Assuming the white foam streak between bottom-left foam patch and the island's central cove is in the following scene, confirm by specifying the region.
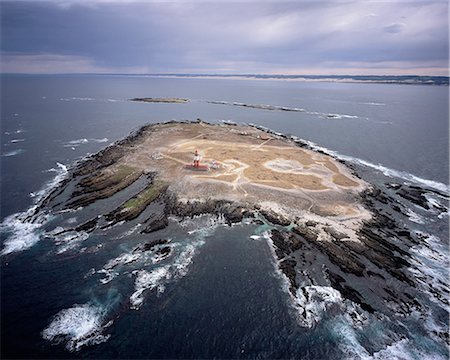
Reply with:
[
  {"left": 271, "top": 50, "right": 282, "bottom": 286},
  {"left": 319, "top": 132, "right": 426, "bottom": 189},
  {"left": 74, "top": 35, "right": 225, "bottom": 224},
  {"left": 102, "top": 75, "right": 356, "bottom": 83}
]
[{"left": 130, "top": 265, "right": 171, "bottom": 310}]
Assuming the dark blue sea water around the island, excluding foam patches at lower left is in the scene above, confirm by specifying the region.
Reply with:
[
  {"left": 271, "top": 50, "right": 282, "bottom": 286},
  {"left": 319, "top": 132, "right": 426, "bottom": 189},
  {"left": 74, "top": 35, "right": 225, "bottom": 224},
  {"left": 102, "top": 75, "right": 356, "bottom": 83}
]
[{"left": 1, "top": 76, "right": 449, "bottom": 358}]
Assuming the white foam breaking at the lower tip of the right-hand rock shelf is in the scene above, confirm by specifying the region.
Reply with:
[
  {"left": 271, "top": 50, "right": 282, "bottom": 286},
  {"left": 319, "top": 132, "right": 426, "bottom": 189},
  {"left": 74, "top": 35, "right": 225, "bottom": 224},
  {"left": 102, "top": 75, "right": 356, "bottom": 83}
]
[{"left": 295, "top": 285, "right": 343, "bottom": 328}]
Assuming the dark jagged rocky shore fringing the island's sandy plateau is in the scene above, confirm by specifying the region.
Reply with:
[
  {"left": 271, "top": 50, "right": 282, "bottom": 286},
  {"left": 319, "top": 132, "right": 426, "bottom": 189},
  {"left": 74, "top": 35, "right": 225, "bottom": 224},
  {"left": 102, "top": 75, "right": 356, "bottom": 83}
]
[{"left": 39, "top": 122, "right": 449, "bottom": 344}]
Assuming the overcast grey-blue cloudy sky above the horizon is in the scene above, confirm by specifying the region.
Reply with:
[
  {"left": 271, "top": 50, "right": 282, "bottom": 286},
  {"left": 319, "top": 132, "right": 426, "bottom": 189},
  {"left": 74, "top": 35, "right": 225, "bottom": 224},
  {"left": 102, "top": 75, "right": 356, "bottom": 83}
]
[{"left": 0, "top": 0, "right": 449, "bottom": 75}]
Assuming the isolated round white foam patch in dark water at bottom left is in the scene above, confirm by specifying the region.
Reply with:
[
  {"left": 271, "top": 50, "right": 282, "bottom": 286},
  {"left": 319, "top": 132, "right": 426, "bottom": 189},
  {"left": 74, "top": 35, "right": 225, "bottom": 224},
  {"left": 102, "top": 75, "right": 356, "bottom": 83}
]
[{"left": 42, "top": 303, "right": 112, "bottom": 351}]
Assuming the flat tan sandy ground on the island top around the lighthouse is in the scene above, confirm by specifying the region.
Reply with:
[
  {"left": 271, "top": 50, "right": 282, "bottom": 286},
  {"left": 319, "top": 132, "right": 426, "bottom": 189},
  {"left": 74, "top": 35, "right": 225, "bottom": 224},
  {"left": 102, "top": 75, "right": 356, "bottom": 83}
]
[{"left": 117, "top": 123, "right": 367, "bottom": 226}]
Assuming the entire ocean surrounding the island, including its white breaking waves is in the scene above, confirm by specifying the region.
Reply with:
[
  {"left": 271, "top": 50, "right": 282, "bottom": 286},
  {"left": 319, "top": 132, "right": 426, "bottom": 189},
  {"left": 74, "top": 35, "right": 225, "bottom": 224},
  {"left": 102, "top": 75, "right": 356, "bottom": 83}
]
[{"left": 0, "top": 75, "right": 449, "bottom": 359}]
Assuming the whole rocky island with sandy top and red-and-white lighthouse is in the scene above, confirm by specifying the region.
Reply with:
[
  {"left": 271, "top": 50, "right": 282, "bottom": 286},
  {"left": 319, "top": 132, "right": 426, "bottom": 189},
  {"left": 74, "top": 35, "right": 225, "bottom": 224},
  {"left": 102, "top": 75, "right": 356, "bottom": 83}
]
[{"left": 36, "top": 120, "right": 448, "bottom": 334}]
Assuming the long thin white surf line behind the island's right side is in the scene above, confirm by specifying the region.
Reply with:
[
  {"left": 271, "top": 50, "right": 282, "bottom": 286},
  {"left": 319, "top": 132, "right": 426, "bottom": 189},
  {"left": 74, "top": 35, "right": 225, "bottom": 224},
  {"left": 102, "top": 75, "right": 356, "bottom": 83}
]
[{"left": 304, "top": 141, "right": 450, "bottom": 194}]
